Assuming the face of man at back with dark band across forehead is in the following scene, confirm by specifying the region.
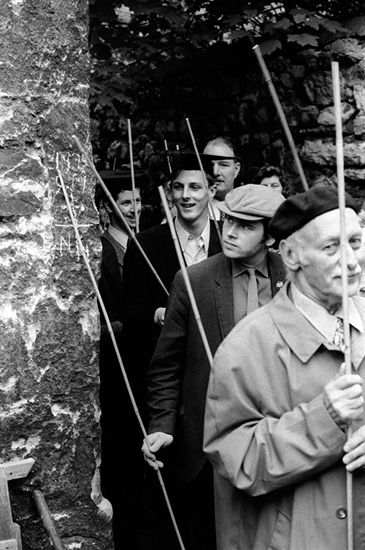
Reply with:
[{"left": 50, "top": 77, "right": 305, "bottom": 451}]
[{"left": 204, "top": 143, "right": 240, "bottom": 201}]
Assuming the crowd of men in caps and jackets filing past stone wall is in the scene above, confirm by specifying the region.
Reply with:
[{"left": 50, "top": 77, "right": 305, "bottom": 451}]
[{"left": 95, "top": 138, "right": 365, "bottom": 550}]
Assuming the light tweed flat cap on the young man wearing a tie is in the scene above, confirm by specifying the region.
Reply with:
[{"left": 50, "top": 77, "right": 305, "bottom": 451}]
[{"left": 218, "top": 183, "right": 285, "bottom": 221}]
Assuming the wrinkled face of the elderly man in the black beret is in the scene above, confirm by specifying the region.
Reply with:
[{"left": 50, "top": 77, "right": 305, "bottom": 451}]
[{"left": 297, "top": 208, "right": 365, "bottom": 309}]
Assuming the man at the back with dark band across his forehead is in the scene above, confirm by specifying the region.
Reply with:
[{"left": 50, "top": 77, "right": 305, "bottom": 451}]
[{"left": 202, "top": 137, "right": 241, "bottom": 220}]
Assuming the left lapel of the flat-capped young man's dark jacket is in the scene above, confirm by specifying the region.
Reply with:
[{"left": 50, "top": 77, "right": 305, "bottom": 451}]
[{"left": 214, "top": 254, "right": 233, "bottom": 339}]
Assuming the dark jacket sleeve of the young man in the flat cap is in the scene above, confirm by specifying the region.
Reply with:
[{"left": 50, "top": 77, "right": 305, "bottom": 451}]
[{"left": 147, "top": 271, "right": 190, "bottom": 435}]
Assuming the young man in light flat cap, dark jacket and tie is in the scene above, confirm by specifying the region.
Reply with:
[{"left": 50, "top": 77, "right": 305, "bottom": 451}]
[{"left": 143, "top": 185, "right": 285, "bottom": 550}]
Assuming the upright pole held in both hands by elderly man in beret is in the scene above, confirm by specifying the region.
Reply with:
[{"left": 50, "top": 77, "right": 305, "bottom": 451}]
[{"left": 331, "top": 62, "right": 353, "bottom": 550}]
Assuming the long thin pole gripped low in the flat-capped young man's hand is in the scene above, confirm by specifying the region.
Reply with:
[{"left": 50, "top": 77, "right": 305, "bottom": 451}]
[{"left": 57, "top": 166, "right": 185, "bottom": 550}]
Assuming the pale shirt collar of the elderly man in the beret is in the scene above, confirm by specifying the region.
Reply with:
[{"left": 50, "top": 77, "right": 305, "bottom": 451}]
[{"left": 291, "top": 283, "right": 364, "bottom": 342}]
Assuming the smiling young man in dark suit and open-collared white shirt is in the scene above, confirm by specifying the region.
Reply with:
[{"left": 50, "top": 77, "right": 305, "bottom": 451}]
[{"left": 122, "top": 153, "right": 222, "bottom": 422}]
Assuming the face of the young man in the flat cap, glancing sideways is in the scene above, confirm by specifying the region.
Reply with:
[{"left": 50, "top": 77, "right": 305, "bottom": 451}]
[{"left": 222, "top": 214, "right": 270, "bottom": 265}]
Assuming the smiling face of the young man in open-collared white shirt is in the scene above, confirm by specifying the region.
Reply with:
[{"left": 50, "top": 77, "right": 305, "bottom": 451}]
[{"left": 171, "top": 170, "right": 214, "bottom": 227}]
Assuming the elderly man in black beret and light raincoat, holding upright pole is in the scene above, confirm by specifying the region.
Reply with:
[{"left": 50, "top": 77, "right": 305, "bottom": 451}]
[{"left": 204, "top": 187, "right": 365, "bottom": 550}]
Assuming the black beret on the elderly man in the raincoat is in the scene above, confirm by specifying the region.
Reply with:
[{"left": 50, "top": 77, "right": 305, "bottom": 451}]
[{"left": 269, "top": 185, "right": 358, "bottom": 241}]
